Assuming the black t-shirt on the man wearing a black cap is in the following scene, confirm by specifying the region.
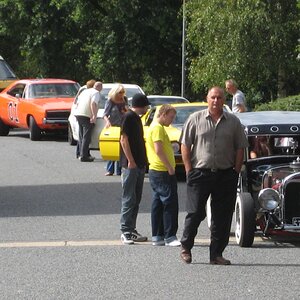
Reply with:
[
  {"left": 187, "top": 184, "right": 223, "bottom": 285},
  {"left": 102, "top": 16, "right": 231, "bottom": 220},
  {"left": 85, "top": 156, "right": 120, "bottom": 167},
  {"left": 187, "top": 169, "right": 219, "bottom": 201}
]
[{"left": 120, "top": 110, "right": 147, "bottom": 168}]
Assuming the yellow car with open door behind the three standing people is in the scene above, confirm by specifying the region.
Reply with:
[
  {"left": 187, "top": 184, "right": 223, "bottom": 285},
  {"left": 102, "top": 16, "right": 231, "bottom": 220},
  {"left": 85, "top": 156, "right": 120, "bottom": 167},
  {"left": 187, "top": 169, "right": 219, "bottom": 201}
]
[{"left": 99, "top": 102, "right": 231, "bottom": 166}]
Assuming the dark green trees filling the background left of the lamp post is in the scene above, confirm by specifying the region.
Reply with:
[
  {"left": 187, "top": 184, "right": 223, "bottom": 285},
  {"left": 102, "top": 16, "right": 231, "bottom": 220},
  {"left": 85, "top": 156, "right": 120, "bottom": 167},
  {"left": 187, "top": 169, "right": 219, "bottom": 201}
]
[{"left": 0, "top": 0, "right": 182, "bottom": 93}]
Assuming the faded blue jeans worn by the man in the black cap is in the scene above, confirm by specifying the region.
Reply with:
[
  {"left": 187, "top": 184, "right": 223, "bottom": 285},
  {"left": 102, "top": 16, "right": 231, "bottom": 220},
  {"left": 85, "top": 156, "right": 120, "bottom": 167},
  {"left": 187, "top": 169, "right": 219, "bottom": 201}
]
[{"left": 120, "top": 168, "right": 145, "bottom": 232}]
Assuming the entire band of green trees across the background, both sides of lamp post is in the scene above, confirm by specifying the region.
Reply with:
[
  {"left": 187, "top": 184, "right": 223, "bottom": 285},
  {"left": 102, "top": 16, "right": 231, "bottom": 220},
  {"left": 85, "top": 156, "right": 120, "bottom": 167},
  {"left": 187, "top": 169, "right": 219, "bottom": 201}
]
[{"left": 0, "top": 0, "right": 300, "bottom": 102}]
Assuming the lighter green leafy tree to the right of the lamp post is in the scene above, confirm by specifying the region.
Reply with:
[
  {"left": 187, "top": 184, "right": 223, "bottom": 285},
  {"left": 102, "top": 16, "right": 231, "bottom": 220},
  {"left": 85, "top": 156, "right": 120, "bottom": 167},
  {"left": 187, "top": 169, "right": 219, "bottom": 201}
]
[{"left": 187, "top": 0, "right": 300, "bottom": 102}]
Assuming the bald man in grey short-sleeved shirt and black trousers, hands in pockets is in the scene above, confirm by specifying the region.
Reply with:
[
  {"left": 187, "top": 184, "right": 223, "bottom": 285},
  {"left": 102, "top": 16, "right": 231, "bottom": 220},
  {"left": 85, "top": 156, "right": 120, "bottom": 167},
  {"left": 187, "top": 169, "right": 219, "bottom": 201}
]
[{"left": 180, "top": 87, "right": 248, "bottom": 265}]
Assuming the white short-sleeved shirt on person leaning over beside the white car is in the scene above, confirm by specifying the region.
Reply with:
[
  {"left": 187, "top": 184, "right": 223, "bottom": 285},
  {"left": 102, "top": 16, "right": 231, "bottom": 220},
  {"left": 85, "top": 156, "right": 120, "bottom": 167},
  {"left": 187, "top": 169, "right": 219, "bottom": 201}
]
[{"left": 74, "top": 88, "right": 101, "bottom": 118}]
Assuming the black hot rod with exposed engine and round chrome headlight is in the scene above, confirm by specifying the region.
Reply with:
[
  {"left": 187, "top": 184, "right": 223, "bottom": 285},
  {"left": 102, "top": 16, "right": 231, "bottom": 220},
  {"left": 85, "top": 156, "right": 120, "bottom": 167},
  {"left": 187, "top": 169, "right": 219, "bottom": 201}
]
[{"left": 234, "top": 111, "right": 300, "bottom": 247}]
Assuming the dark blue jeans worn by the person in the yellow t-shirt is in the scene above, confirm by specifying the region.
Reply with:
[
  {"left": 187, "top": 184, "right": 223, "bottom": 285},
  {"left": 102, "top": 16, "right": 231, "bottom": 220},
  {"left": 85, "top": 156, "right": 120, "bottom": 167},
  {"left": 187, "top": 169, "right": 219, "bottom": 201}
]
[{"left": 149, "top": 170, "right": 178, "bottom": 243}]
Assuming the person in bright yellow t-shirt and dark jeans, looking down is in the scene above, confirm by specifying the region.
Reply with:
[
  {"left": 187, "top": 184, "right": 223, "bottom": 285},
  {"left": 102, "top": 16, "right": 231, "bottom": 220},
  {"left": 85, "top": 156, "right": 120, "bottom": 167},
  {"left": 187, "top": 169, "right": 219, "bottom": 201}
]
[{"left": 146, "top": 104, "right": 181, "bottom": 246}]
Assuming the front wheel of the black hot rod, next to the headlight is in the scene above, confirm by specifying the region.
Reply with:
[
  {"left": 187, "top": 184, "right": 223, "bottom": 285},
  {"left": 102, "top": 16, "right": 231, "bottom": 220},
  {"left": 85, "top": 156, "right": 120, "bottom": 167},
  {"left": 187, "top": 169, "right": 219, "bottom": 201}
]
[{"left": 234, "top": 193, "right": 255, "bottom": 247}]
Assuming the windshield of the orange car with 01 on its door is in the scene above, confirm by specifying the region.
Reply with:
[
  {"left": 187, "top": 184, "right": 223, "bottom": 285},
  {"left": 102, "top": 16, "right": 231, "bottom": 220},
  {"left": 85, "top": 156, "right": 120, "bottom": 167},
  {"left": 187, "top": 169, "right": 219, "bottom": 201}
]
[{"left": 28, "top": 83, "right": 78, "bottom": 98}]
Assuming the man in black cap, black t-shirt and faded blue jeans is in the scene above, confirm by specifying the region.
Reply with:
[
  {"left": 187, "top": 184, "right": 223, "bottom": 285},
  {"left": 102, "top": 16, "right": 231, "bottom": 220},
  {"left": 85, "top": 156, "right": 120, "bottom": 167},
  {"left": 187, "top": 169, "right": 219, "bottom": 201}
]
[{"left": 120, "top": 94, "right": 150, "bottom": 245}]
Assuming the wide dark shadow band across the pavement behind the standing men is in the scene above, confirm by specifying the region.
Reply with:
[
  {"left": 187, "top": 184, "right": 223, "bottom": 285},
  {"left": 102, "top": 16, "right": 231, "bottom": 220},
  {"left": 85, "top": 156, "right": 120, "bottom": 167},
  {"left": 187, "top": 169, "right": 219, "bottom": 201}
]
[{"left": 0, "top": 182, "right": 188, "bottom": 218}]
